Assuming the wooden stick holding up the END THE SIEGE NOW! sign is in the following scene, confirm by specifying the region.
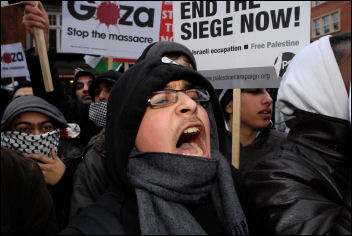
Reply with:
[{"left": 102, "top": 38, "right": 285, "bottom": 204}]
[{"left": 232, "top": 89, "right": 241, "bottom": 169}]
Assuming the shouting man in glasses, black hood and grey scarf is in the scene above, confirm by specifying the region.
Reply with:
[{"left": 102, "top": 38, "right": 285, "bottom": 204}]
[{"left": 61, "top": 56, "right": 248, "bottom": 235}]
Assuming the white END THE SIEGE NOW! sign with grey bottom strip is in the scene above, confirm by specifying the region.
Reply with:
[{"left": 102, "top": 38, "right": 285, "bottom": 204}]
[{"left": 173, "top": 1, "right": 310, "bottom": 88}]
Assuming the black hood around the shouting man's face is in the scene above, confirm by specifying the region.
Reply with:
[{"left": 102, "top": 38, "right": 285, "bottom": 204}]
[{"left": 105, "top": 57, "right": 226, "bottom": 190}]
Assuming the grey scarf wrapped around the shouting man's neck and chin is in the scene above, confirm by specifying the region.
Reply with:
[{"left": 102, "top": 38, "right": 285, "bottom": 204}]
[{"left": 128, "top": 152, "right": 248, "bottom": 235}]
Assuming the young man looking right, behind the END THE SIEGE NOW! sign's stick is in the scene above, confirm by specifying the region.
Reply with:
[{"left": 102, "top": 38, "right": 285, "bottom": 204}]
[{"left": 219, "top": 88, "right": 286, "bottom": 174}]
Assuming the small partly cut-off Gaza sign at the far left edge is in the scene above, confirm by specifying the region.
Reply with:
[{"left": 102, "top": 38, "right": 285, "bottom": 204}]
[{"left": 1, "top": 43, "right": 29, "bottom": 78}]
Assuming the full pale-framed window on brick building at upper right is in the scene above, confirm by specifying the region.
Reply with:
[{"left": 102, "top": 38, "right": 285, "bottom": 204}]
[{"left": 312, "top": 11, "right": 340, "bottom": 38}]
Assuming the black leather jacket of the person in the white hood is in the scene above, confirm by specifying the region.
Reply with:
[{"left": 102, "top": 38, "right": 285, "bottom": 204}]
[{"left": 242, "top": 110, "right": 351, "bottom": 235}]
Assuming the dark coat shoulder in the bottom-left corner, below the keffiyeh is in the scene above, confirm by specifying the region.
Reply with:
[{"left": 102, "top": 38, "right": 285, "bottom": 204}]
[{"left": 1, "top": 147, "right": 58, "bottom": 235}]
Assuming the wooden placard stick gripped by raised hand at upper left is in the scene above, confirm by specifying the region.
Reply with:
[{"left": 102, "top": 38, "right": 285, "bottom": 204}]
[{"left": 34, "top": 1, "right": 54, "bottom": 92}]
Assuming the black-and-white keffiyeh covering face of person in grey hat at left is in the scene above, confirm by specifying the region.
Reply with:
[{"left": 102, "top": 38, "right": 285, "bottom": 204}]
[{"left": 1, "top": 129, "right": 60, "bottom": 158}]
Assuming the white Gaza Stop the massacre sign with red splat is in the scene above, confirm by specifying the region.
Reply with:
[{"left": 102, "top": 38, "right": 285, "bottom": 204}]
[{"left": 61, "top": 1, "right": 162, "bottom": 59}]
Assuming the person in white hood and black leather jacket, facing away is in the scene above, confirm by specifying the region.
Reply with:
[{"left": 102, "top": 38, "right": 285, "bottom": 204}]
[{"left": 242, "top": 32, "right": 351, "bottom": 235}]
